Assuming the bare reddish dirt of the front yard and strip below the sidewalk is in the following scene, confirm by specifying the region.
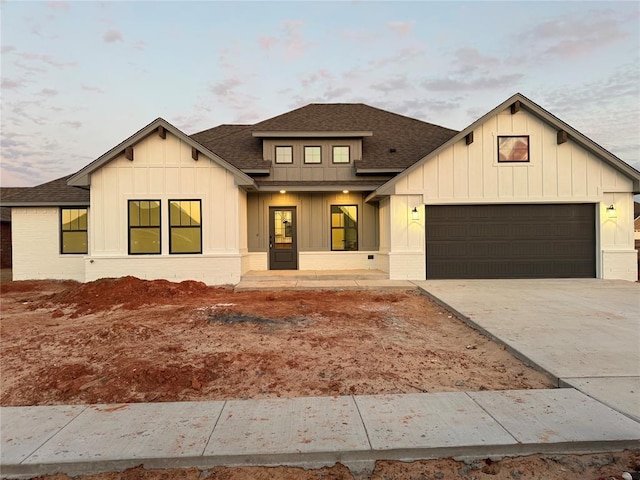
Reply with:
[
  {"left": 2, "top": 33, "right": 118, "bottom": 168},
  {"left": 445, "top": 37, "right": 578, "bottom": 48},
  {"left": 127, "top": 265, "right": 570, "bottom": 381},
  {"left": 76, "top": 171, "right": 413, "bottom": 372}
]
[{"left": 0, "top": 277, "right": 640, "bottom": 480}]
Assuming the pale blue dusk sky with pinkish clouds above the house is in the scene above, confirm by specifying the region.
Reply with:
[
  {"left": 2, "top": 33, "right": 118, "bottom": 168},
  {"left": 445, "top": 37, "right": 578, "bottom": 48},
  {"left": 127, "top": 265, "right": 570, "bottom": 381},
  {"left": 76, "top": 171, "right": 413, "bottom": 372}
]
[{"left": 0, "top": 1, "right": 640, "bottom": 187}]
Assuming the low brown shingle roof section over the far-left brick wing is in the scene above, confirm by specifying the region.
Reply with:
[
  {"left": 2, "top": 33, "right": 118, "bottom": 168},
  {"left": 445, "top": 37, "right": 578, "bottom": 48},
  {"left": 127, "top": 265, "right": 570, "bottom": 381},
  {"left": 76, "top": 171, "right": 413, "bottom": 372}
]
[{"left": 0, "top": 175, "right": 89, "bottom": 207}]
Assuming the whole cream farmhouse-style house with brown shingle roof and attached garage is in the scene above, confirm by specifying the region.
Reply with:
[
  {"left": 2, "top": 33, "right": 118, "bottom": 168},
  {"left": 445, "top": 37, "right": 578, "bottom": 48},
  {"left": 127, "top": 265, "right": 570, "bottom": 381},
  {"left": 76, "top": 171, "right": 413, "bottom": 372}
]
[{"left": 1, "top": 94, "right": 640, "bottom": 285}]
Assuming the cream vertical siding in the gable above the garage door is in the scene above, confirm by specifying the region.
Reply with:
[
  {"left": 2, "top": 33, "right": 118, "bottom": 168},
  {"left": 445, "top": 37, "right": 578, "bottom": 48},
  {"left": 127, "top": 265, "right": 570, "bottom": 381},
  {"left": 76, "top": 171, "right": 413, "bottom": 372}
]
[{"left": 395, "top": 109, "right": 632, "bottom": 203}]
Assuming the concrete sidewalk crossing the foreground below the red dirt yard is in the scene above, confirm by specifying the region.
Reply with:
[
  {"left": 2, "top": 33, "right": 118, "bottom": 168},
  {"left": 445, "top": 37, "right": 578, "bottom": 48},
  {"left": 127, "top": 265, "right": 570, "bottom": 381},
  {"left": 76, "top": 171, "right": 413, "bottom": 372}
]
[{"left": 0, "top": 388, "right": 640, "bottom": 478}]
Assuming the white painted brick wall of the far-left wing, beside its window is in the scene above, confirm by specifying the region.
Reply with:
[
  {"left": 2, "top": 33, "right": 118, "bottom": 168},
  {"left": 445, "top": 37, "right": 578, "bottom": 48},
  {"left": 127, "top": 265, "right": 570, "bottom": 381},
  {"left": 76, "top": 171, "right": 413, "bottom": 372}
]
[{"left": 11, "top": 207, "right": 85, "bottom": 282}]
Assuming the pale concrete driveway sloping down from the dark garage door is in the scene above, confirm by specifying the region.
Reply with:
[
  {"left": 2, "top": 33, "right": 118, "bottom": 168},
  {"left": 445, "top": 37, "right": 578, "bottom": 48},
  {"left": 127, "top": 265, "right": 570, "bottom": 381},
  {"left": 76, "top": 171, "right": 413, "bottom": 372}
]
[{"left": 415, "top": 279, "right": 640, "bottom": 420}]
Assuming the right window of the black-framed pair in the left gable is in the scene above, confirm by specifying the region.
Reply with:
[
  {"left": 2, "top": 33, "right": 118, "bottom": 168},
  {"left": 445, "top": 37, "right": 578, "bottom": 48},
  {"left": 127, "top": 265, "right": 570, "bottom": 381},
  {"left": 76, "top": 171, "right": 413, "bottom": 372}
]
[{"left": 169, "top": 200, "right": 202, "bottom": 253}]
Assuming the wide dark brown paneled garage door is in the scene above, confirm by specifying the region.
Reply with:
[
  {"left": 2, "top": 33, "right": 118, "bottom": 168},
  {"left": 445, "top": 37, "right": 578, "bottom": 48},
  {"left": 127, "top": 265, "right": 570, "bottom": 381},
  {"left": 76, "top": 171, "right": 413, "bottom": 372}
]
[{"left": 426, "top": 204, "right": 596, "bottom": 279}]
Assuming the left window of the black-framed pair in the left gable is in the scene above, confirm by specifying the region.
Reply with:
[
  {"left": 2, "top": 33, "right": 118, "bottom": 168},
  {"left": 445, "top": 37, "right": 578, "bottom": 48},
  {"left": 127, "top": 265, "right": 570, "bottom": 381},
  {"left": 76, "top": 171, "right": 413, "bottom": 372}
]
[{"left": 128, "top": 200, "right": 160, "bottom": 255}]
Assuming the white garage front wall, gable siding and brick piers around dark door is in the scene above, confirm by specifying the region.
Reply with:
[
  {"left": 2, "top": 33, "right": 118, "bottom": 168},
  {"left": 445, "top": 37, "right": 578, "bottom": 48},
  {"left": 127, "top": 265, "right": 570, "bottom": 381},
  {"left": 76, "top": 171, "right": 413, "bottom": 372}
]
[{"left": 390, "top": 109, "right": 637, "bottom": 280}]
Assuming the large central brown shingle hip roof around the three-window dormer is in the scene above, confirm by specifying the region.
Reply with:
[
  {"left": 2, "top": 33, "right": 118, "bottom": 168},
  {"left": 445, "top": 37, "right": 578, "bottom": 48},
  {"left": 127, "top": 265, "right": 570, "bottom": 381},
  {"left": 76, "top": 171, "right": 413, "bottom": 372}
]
[{"left": 191, "top": 103, "right": 458, "bottom": 170}]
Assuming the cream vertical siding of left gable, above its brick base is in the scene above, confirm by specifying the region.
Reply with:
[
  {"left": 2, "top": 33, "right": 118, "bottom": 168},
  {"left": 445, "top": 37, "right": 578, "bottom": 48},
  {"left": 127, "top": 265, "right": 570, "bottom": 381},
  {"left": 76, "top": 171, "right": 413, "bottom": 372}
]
[{"left": 90, "top": 133, "right": 240, "bottom": 256}]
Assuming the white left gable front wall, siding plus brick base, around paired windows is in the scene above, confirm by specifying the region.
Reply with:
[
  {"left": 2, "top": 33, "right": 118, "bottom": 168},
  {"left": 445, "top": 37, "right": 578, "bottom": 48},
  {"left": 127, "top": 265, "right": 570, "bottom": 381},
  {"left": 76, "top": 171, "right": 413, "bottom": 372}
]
[{"left": 85, "top": 133, "right": 246, "bottom": 284}]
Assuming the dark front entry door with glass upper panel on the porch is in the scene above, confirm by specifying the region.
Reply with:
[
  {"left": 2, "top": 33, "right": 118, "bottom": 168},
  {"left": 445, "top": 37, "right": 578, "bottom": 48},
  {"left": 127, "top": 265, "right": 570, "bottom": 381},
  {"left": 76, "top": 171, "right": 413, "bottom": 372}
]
[{"left": 269, "top": 207, "right": 298, "bottom": 270}]
